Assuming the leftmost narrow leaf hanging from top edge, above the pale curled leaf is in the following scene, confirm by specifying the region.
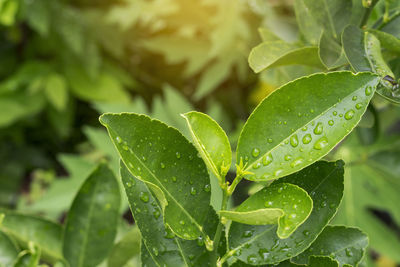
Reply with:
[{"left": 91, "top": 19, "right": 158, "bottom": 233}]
[{"left": 294, "top": 0, "right": 322, "bottom": 45}]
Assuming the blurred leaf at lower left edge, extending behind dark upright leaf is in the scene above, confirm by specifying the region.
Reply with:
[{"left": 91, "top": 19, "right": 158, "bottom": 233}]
[{"left": 0, "top": 210, "right": 62, "bottom": 263}]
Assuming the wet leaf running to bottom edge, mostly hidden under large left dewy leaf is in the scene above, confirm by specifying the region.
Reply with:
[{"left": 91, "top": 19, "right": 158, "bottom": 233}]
[{"left": 121, "top": 163, "right": 218, "bottom": 266}]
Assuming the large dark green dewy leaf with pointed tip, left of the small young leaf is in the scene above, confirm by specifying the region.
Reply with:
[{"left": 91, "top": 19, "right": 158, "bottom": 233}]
[{"left": 100, "top": 113, "right": 211, "bottom": 240}]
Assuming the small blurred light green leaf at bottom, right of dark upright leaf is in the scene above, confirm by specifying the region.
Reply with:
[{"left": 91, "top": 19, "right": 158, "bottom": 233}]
[{"left": 107, "top": 226, "right": 141, "bottom": 267}]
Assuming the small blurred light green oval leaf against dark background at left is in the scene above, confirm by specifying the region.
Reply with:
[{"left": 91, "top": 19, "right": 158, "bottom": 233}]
[{"left": 44, "top": 74, "right": 68, "bottom": 110}]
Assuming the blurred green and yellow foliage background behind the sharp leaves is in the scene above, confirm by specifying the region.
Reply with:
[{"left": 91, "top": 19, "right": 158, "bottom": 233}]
[{"left": 0, "top": 0, "right": 400, "bottom": 266}]
